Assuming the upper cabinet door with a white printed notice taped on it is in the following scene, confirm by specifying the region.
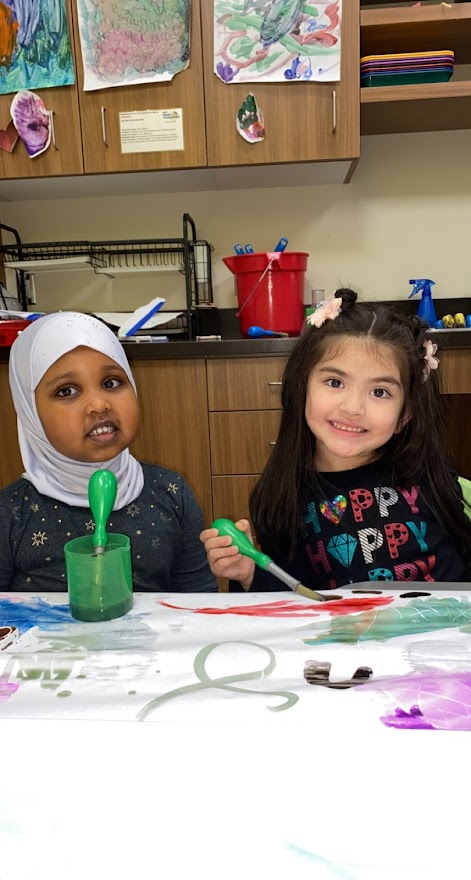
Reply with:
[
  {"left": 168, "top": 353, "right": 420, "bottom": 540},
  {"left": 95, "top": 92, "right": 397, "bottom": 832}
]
[{"left": 74, "top": 0, "right": 206, "bottom": 174}]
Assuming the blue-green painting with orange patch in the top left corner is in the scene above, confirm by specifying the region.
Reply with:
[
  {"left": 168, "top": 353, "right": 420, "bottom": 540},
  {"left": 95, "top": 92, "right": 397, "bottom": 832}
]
[{"left": 0, "top": 0, "right": 75, "bottom": 95}]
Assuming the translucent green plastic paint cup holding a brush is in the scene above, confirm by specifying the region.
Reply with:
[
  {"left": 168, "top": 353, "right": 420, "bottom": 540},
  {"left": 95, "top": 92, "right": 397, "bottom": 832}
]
[{"left": 64, "top": 535, "right": 132, "bottom": 621}]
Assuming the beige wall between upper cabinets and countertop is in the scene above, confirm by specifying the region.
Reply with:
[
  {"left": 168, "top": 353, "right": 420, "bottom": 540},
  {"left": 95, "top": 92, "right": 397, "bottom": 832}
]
[{"left": 0, "top": 131, "right": 471, "bottom": 310}]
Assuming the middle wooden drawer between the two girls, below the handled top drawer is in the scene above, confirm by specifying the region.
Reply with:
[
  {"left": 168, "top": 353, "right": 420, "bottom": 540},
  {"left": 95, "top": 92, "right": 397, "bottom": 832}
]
[{"left": 209, "top": 410, "right": 281, "bottom": 474}]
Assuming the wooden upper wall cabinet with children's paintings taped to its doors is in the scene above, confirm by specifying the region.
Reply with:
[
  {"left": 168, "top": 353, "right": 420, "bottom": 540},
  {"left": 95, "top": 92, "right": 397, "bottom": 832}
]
[{"left": 0, "top": 0, "right": 360, "bottom": 179}]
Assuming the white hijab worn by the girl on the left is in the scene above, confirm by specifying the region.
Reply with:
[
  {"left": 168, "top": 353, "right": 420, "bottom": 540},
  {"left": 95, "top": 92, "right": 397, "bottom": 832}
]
[{"left": 10, "top": 312, "right": 144, "bottom": 510}]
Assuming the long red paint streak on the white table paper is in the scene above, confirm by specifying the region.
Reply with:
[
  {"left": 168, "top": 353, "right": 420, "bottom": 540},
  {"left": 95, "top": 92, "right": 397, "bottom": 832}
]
[{"left": 156, "top": 596, "right": 393, "bottom": 618}]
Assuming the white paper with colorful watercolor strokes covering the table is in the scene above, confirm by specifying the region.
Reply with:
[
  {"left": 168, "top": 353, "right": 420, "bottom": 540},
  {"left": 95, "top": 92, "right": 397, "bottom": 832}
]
[{"left": 0, "top": 590, "right": 471, "bottom": 738}]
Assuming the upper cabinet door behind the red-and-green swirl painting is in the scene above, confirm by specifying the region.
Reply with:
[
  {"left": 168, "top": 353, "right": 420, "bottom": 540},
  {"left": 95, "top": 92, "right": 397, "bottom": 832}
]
[{"left": 202, "top": 0, "right": 360, "bottom": 166}]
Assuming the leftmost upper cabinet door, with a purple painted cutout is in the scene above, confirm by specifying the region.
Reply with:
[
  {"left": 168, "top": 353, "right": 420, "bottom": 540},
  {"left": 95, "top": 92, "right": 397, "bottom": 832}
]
[{"left": 0, "top": 0, "right": 83, "bottom": 180}]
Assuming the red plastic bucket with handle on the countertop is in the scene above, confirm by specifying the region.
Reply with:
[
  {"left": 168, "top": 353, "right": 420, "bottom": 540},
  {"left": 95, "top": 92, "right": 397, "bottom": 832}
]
[{"left": 223, "top": 251, "right": 309, "bottom": 336}]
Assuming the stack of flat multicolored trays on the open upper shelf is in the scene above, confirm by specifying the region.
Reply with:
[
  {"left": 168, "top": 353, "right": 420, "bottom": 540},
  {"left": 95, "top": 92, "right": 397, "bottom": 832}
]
[{"left": 360, "top": 49, "right": 455, "bottom": 87}]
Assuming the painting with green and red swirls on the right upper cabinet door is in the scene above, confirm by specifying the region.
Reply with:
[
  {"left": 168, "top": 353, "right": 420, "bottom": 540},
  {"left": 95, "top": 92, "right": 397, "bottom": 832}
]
[{"left": 214, "top": 0, "right": 342, "bottom": 83}]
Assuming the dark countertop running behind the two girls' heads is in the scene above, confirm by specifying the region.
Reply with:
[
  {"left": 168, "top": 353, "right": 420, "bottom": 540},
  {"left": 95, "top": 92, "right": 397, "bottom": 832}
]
[{"left": 0, "top": 329, "right": 471, "bottom": 363}]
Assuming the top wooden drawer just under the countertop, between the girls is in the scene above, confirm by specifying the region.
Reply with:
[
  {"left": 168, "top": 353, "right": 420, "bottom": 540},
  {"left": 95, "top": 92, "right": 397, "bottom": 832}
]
[{"left": 208, "top": 357, "right": 287, "bottom": 411}]
